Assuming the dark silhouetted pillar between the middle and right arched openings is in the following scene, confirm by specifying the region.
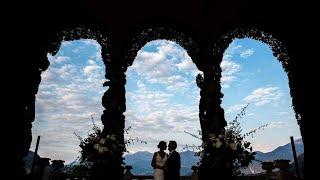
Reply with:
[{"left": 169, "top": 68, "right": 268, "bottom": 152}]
[{"left": 197, "top": 43, "right": 231, "bottom": 179}]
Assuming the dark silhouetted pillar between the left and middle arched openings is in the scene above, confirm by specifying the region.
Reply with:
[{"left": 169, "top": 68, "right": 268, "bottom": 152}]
[{"left": 93, "top": 44, "right": 125, "bottom": 180}]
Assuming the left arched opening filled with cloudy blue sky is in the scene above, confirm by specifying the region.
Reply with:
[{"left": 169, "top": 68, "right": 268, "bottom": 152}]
[{"left": 27, "top": 39, "right": 105, "bottom": 173}]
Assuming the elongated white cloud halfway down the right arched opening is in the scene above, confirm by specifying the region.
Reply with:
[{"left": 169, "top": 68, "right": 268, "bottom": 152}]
[{"left": 244, "top": 87, "right": 283, "bottom": 106}]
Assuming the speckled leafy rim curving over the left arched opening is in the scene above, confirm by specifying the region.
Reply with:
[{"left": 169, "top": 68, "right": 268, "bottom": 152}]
[{"left": 21, "top": 26, "right": 110, "bottom": 165}]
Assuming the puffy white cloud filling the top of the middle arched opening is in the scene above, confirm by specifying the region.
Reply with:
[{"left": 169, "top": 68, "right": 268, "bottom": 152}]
[{"left": 127, "top": 40, "right": 199, "bottom": 91}]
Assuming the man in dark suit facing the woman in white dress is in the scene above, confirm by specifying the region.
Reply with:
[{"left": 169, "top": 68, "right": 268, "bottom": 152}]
[{"left": 165, "top": 141, "right": 181, "bottom": 180}]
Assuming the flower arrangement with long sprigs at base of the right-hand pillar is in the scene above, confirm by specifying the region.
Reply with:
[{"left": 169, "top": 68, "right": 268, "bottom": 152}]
[{"left": 185, "top": 104, "right": 268, "bottom": 176}]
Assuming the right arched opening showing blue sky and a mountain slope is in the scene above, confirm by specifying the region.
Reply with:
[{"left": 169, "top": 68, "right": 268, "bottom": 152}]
[{"left": 221, "top": 38, "right": 304, "bottom": 174}]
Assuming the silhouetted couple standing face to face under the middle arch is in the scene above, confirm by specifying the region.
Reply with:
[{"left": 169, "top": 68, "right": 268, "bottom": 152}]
[{"left": 151, "top": 141, "right": 181, "bottom": 180}]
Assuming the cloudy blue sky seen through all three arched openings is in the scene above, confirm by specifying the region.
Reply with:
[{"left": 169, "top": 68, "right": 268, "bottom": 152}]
[{"left": 31, "top": 39, "right": 300, "bottom": 163}]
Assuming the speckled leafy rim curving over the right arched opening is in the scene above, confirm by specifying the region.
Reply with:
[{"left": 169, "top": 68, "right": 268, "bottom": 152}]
[{"left": 213, "top": 25, "right": 304, "bottom": 143}]
